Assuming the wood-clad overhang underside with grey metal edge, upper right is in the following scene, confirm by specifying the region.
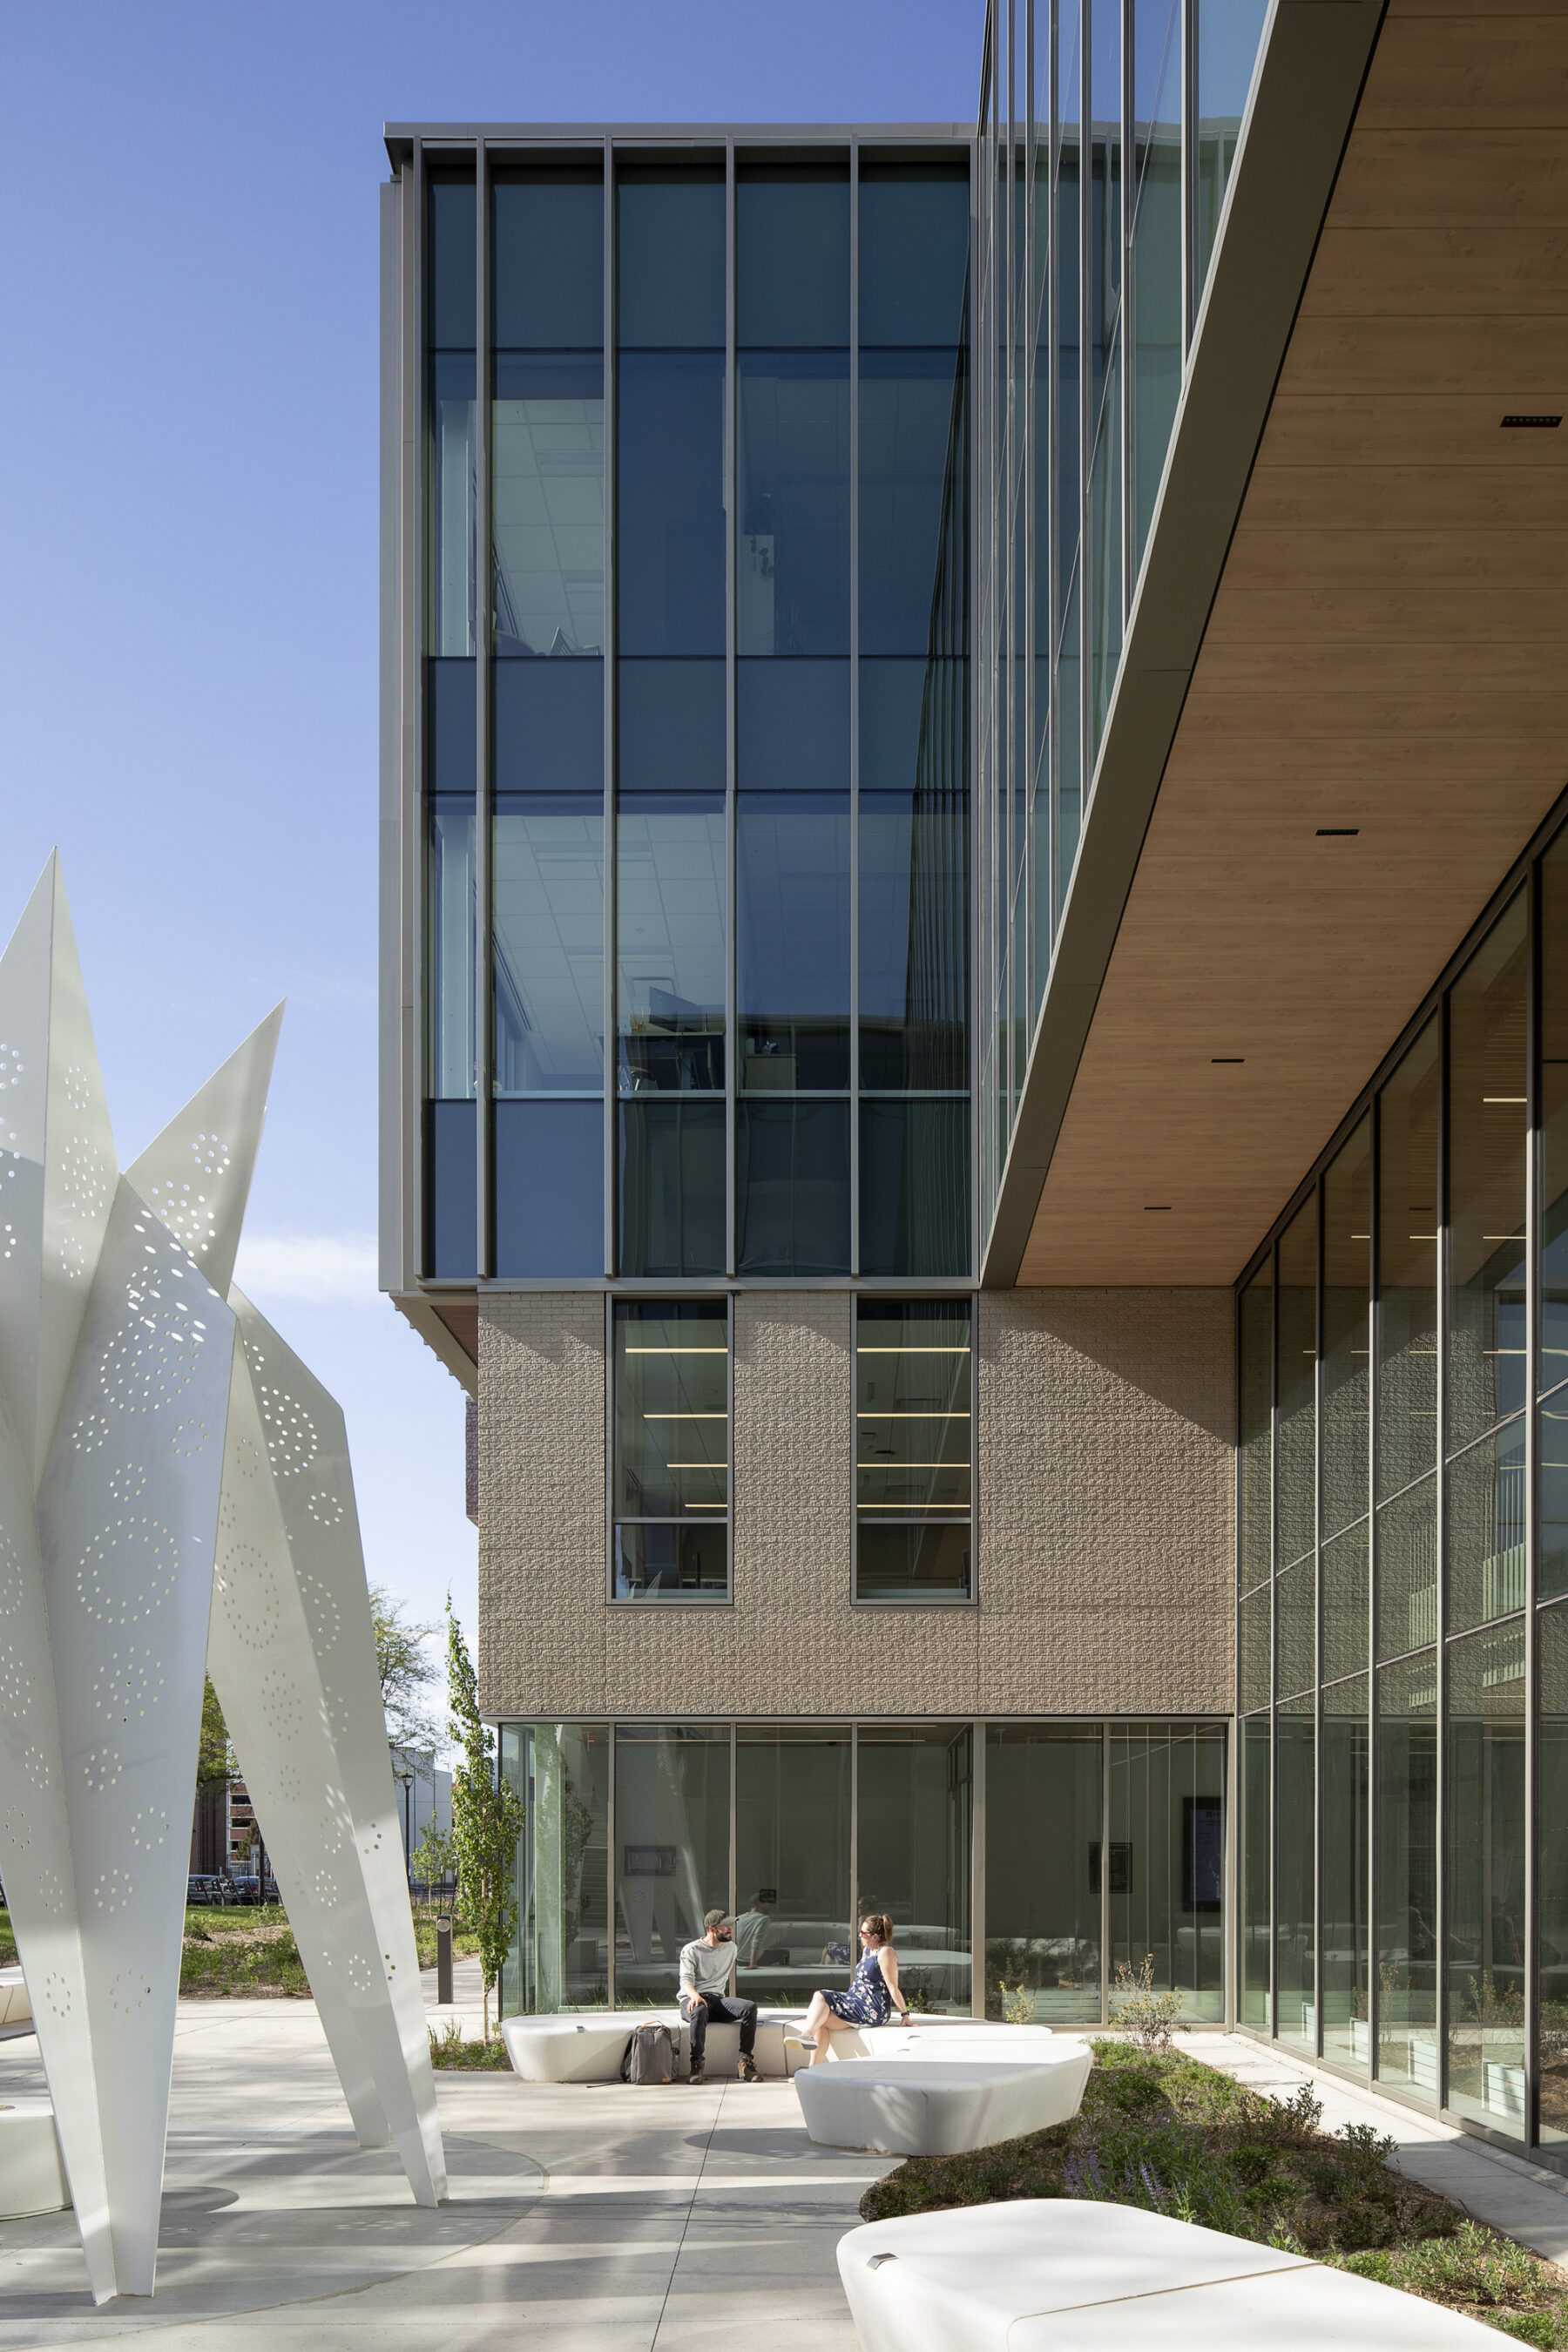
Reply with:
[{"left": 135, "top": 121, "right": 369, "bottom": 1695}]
[{"left": 983, "top": 0, "right": 1568, "bottom": 1287}]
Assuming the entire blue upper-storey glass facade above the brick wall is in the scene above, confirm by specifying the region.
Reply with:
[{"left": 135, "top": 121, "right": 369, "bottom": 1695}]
[{"left": 421, "top": 141, "right": 973, "bottom": 1282}]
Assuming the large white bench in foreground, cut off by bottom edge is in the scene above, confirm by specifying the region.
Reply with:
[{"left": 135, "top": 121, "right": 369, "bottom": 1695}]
[{"left": 841, "top": 2192, "right": 1497, "bottom": 2352}]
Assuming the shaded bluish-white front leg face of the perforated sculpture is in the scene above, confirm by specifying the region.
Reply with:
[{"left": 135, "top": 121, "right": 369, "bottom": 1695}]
[{"left": 37, "top": 1180, "right": 233, "bottom": 2295}]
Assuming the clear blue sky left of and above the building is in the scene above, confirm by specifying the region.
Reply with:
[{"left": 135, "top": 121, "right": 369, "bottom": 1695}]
[{"left": 0, "top": 0, "right": 983, "bottom": 1731}]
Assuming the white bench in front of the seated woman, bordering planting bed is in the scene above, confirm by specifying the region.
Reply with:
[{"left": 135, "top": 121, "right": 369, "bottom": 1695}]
[{"left": 794, "top": 2039, "right": 1093, "bottom": 2157}]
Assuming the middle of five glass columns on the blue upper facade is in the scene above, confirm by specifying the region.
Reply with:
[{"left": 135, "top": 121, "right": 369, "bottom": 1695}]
[{"left": 616, "top": 155, "right": 729, "bottom": 1277}]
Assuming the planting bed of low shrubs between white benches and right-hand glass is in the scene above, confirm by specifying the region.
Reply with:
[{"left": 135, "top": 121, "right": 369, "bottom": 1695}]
[{"left": 861, "top": 2042, "right": 1568, "bottom": 2352}]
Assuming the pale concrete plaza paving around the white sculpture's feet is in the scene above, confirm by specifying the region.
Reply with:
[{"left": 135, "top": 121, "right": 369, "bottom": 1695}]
[{"left": 0, "top": 1964, "right": 891, "bottom": 2352}]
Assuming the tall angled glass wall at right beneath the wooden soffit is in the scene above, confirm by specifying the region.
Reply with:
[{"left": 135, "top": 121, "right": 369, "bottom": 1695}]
[{"left": 1236, "top": 814, "right": 1568, "bottom": 2147}]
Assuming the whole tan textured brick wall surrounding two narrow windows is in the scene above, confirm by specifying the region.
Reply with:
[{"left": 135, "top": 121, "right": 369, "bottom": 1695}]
[{"left": 480, "top": 1291, "right": 1232, "bottom": 1717}]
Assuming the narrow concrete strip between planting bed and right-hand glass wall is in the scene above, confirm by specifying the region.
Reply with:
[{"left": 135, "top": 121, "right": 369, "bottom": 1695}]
[{"left": 1175, "top": 2035, "right": 1568, "bottom": 2268}]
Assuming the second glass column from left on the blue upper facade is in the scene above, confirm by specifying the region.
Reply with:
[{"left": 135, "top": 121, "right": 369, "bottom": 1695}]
[{"left": 489, "top": 160, "right": 605, "bottom": 1277}]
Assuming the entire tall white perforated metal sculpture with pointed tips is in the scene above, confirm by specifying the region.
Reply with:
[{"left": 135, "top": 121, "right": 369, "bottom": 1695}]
[{"left": 0, "top": 859, "right": 447, "bottom": 2301}]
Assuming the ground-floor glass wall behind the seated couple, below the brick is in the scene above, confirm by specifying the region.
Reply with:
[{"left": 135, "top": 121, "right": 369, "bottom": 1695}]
[{"left": 501, "top": 1721, "right": 1227, "bottom": 2023}]
